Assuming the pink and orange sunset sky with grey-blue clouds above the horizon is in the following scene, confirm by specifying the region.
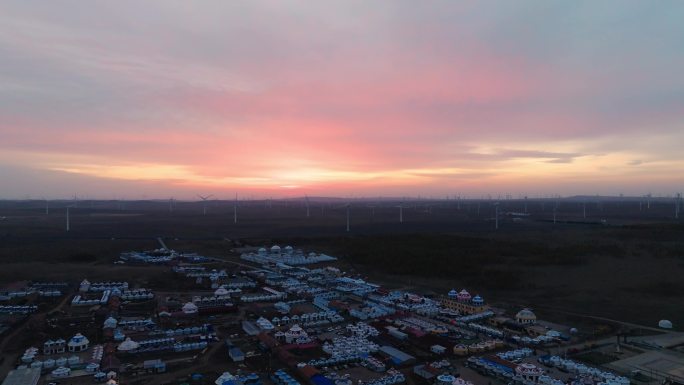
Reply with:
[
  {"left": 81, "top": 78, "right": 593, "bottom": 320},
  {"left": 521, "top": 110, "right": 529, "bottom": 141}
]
[{"left": 0, "top": 0, "right": 684, "bottom": 199}]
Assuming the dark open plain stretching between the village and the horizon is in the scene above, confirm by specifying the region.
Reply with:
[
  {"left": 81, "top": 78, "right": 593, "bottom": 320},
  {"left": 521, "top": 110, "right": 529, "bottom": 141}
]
[{"left": 0, "top": 199, "right": 684, "bottom": 329}]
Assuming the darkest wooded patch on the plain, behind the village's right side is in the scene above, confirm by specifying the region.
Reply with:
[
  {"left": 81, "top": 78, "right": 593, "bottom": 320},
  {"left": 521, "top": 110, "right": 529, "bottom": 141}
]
[{"left": 273, "top": 225, "right": 684, "bottom": 289}]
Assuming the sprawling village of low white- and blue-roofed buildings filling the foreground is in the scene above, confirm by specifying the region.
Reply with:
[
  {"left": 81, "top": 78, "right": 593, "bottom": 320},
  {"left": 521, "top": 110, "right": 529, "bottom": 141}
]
[{"left": 0, "top": 245, "right": 684, "bottom": 385}]
